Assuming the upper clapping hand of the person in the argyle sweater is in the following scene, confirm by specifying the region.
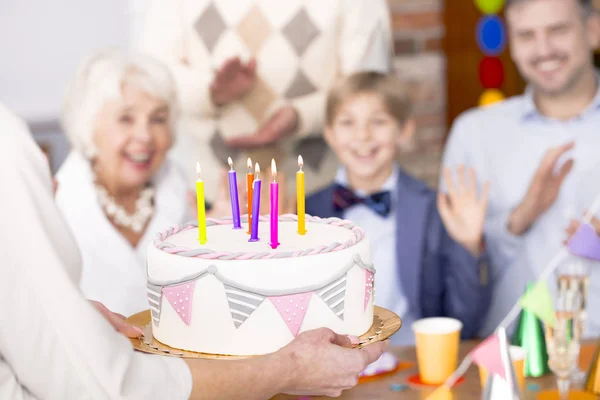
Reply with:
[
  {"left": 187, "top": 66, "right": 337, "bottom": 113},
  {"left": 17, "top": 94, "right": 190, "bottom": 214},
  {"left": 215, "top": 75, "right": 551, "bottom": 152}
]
[{"left": 210, "top": 57, "right": 256, "bottom": 107}]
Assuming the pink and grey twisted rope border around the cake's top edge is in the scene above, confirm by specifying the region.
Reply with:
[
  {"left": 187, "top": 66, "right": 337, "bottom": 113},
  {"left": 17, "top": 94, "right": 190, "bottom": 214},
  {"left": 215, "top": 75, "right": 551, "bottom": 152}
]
[{"left": 153, "top": 214, "right": 365, "bottom": 260}]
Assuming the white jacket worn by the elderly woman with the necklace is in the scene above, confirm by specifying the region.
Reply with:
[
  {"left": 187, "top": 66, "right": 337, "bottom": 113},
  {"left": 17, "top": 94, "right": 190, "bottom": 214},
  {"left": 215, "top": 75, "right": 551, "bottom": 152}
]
[{"left": 56, "top": 152, "right": 189, "bottom": 316}]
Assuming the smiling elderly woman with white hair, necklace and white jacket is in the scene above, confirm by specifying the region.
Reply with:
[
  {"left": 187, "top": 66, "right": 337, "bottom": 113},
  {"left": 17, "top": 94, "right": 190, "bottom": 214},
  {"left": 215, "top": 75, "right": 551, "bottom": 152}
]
[{"left": 56, "top": 51, "right": 189, "bottom": 315}]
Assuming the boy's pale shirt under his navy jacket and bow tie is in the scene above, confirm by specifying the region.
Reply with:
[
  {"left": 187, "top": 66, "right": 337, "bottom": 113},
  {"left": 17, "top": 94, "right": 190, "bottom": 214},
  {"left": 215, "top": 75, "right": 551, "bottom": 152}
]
[{"left": 335, "top": 166, "right": 414, "bottom": 345}]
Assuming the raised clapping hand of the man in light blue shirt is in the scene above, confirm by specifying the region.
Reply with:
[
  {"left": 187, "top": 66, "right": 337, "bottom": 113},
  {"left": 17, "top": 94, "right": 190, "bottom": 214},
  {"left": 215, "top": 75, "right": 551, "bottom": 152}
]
[{"left": 508, "top": 142, "right": 575, "bottom": 236}]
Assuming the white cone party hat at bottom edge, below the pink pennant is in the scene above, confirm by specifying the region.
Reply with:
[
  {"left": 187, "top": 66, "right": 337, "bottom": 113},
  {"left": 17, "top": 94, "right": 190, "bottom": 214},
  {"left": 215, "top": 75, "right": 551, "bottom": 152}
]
[{"left": 482, "top": 327, "right": 521, "bottom": 400}]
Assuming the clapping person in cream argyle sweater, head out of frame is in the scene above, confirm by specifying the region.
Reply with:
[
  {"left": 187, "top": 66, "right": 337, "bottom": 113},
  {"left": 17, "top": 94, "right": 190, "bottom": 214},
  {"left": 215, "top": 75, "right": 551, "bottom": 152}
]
[{"left": 138, "top": 0, "right": 393, "bottom": 203}]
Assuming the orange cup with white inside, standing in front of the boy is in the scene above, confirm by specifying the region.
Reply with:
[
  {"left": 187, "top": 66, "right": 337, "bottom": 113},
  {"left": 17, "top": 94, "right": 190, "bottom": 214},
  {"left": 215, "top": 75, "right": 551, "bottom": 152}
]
[{"left": 412, "top": 318, "right": 463, "bottom": 385}]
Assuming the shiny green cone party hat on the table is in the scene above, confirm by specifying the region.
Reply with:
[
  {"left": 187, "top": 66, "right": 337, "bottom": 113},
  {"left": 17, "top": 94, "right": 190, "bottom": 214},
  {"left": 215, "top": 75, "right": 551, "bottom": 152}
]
[{"left": 512, "top": 284, "right": 550, "bottom": 378}]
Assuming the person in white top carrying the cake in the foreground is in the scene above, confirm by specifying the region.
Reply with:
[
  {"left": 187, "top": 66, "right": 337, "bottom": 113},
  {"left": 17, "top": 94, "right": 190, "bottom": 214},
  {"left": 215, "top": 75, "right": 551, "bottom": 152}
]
[{"left": 0, "top": 102, "right": 387, "bottom": 400}]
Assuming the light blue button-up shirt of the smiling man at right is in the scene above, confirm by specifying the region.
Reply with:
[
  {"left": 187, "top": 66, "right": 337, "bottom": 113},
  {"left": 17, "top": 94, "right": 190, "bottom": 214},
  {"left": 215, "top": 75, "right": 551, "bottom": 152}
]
[{"left": 440, "top": 78, "right": 600, "bottom": 336}]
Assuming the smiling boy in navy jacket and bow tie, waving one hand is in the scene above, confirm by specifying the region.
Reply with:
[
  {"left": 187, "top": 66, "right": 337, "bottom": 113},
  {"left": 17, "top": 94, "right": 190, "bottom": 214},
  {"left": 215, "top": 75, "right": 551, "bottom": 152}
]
[{"left": 306, "top": 72, "right": 490, "bottom": 344}]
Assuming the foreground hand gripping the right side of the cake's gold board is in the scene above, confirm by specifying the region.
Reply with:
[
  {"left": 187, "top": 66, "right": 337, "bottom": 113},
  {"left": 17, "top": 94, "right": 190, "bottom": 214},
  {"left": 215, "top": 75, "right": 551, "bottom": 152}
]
[{"left": 272, "top": 328, "right": 389, "bottom": 397}]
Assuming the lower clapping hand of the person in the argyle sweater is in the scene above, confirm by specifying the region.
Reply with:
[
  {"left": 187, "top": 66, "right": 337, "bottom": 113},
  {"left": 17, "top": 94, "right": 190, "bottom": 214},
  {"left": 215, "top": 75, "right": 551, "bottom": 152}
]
[{"left": 227, "top": 106, "right": 298, "bottom": 149}]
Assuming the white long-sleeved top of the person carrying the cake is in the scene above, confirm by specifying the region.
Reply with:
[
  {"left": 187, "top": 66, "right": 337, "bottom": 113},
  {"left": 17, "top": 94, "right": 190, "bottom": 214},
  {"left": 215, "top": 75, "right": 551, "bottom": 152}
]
[{"left": 0, "top": 107, "right": 192, "bottom": 400}]
